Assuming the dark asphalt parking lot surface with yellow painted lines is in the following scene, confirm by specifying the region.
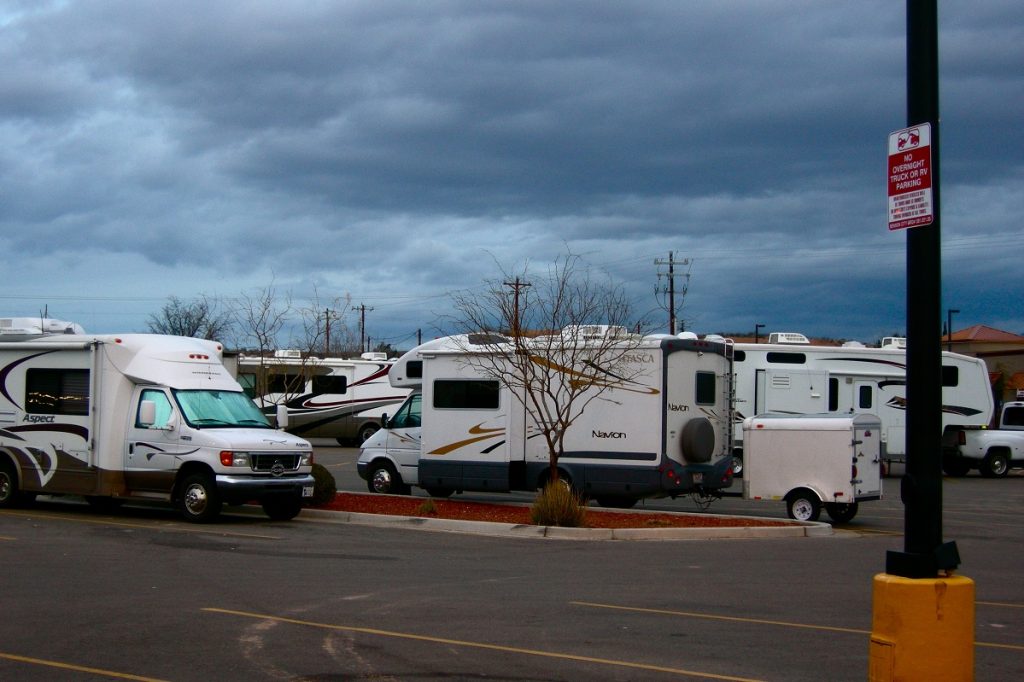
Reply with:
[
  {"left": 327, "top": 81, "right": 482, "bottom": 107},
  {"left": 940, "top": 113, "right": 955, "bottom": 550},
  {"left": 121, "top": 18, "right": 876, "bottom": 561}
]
[{"left": 0, "top": 447, "right": 1024, "bottom": 681}]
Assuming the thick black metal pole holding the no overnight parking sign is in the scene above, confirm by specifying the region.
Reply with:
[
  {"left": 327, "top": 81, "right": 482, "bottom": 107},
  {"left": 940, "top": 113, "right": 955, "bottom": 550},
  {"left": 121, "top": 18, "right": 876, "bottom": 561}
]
[{"left": 886, "top": 0, "right": 959, "bottom": 579}]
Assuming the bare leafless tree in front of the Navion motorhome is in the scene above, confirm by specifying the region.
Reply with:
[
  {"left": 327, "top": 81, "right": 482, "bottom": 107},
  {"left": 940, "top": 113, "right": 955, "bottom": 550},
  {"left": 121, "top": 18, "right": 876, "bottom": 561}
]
[{"left": 454, "top": 254, "right": 642, "bottom": 480}]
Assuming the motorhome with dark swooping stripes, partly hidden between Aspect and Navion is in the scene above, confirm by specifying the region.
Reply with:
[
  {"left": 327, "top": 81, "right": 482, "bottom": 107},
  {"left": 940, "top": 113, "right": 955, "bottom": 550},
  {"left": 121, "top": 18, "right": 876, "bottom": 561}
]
[{"left": 237, "top": 350, "right": 409, "bottom": 444}]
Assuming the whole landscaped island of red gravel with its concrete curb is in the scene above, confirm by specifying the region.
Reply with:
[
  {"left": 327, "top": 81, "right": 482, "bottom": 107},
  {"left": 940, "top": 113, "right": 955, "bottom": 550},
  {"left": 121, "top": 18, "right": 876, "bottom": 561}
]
[{"left": 302, "top": 493, "right": 833, "bottom": 540}]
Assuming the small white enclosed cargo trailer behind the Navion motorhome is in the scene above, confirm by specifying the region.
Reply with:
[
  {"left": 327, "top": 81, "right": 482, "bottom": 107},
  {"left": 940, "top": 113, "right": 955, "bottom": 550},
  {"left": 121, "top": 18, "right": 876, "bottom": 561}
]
[{"left": 743, "top": 414, "right": 882, "bottom": 523}]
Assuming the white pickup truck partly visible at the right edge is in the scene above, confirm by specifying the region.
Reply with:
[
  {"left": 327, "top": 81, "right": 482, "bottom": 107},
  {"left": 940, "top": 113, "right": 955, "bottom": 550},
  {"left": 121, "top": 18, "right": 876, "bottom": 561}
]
[{"left": 942, "top": 400, "right": 1024, "bottom": 478}]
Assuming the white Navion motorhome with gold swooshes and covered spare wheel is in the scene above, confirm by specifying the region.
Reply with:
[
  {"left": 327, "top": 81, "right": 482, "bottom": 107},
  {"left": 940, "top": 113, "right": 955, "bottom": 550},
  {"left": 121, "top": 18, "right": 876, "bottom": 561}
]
[{"left": 357, "top": 329, "right": 732, "bottom": 507}]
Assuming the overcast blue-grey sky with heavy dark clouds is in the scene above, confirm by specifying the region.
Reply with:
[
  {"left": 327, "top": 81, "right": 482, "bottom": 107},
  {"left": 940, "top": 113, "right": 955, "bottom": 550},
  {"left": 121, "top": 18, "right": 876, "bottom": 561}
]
[{"left": 0, "top": 0, "right": 1024, "bottom": 348}]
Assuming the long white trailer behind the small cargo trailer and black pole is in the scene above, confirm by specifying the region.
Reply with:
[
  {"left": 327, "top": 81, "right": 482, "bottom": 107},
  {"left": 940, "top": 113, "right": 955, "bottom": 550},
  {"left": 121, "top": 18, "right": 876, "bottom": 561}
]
[{"left": 733, "top": 333, "right": 993, "bottom": 472}]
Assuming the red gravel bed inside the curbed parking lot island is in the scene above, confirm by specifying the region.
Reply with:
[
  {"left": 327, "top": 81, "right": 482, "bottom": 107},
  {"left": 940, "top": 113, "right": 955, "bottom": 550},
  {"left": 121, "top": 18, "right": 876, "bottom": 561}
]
[{"left": 313, "top": 493, "right": 792, "bottom": 528}]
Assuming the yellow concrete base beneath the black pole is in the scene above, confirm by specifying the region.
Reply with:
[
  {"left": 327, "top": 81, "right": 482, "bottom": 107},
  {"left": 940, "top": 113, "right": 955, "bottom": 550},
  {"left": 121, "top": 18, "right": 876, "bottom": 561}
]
[{"left": 867, "top": 573, "right": 974, "bottom": 682}]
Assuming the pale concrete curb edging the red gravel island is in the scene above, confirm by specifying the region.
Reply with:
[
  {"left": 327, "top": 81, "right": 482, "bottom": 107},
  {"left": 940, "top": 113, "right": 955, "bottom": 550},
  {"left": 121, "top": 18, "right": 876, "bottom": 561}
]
[{"left": 298, "top": 509, "right": 834, "bottom": 541}]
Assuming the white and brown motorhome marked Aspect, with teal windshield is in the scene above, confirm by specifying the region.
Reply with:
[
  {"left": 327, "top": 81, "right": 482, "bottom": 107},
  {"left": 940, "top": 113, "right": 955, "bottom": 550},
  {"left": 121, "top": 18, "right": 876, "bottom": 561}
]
[{"left": 0, "top": 327, "right": 313, "bottom": 522}]
